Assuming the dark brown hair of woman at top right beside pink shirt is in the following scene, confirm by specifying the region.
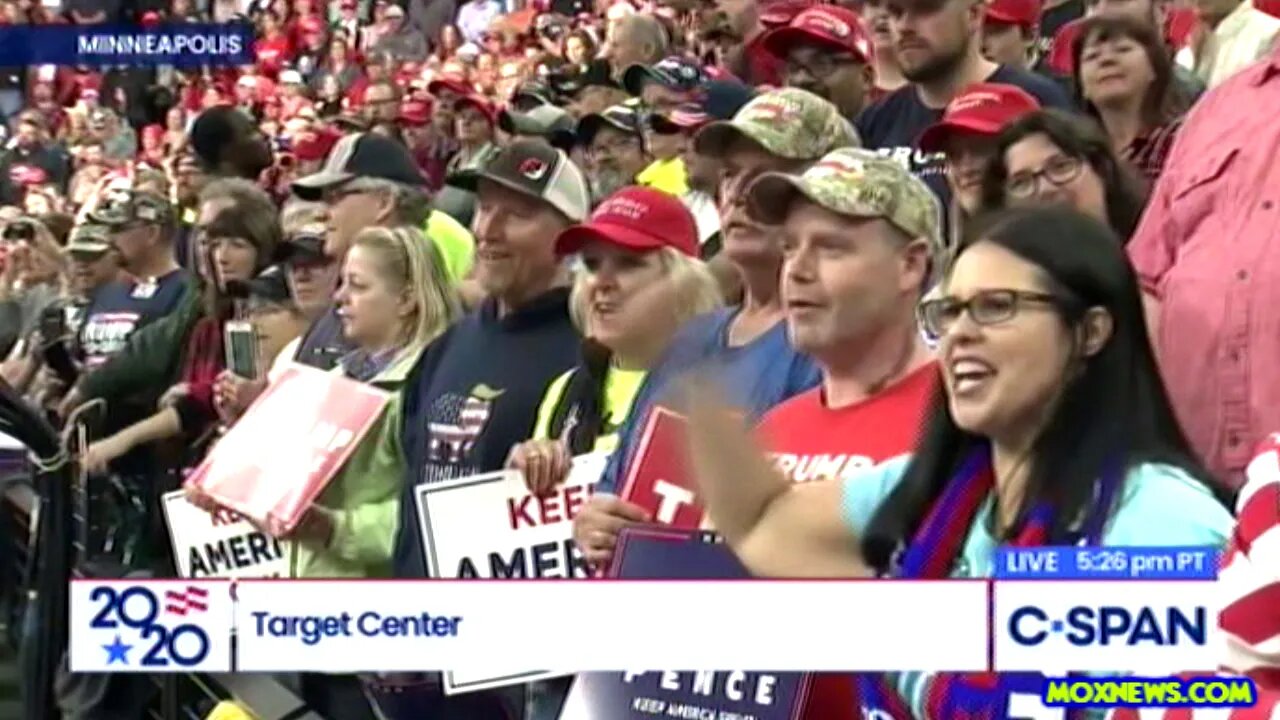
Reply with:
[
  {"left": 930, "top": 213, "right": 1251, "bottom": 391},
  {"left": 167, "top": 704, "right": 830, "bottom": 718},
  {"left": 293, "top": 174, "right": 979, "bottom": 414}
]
[{"left": 1071, "top": 14, "right": 1192, "bottom": 128}]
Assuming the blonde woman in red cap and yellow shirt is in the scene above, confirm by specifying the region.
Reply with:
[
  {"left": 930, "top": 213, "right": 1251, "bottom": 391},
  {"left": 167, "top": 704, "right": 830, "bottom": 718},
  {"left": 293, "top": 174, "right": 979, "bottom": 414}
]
[{"left": 508, "top": 187, "right": 721, "bottom": 495}]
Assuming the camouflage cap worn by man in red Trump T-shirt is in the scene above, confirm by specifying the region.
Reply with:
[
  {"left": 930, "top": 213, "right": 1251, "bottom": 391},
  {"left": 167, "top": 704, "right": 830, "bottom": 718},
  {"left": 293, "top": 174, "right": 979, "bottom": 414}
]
[{"left": 748, "top": 147, "right": 942, "bottom": 258}]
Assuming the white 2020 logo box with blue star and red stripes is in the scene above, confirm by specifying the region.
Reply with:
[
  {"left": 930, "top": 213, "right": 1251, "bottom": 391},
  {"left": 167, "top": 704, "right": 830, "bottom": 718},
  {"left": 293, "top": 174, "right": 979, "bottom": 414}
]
[{"left": 70, "top": 580, "right": 234, "bottom": 673}]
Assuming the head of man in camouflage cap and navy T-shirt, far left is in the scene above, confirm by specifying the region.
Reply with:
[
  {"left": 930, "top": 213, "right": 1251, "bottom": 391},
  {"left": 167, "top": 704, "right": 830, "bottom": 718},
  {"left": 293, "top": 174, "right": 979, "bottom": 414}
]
[{"left": 88, "top": 188, "right": 178, "bottom": 282}]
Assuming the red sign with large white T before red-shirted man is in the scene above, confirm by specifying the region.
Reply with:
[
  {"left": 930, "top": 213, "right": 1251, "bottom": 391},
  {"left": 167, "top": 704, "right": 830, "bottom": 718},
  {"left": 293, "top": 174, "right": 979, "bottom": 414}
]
[{"left": 620, "top": 406, "right": 707, "bottom": 530}]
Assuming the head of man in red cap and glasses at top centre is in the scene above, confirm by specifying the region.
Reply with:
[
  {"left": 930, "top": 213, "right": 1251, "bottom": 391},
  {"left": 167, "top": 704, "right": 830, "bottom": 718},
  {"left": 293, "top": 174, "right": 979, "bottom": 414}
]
[{"left": 763, "top": 5, "right": 874, "bottom": 118}]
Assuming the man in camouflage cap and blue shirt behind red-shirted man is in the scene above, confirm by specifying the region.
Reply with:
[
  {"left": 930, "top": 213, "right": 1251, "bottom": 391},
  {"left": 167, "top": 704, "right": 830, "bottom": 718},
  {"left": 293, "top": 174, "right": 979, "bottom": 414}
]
[{"left": 573, "top": 87, "right": 859, "bottom": 561}]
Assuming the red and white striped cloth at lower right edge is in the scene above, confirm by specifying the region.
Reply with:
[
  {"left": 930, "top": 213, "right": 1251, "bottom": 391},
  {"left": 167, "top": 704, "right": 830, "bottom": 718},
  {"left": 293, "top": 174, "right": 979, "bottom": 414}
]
[{"left": 1110, "top": 433, "right": 1280, "bottom": 720}]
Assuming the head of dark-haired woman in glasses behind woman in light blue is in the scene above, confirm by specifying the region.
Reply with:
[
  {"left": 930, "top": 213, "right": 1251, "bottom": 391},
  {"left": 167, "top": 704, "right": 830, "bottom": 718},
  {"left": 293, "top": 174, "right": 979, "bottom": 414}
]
[{"left": 982, "top": 110, "right": 1147, "bottom": 242}]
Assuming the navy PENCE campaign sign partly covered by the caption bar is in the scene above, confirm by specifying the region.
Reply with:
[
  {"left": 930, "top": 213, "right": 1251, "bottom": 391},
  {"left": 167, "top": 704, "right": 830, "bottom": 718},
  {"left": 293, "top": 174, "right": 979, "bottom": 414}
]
[{"left": 559, "top": 528, "right": 809, "bottom": 720}]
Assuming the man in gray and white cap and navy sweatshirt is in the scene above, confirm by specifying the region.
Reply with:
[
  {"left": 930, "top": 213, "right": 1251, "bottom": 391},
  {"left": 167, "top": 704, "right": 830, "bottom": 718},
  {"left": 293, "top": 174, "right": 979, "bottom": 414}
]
[{"left": 384, "top": 134, "right": 591, "bottom": 720}]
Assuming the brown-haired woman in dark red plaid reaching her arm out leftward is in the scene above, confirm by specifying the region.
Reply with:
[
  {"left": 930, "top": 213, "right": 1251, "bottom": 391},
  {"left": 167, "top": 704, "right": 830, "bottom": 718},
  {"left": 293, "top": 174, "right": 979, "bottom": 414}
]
[{"left": 81, "top": 179, "right": 280, "bottom": 473}]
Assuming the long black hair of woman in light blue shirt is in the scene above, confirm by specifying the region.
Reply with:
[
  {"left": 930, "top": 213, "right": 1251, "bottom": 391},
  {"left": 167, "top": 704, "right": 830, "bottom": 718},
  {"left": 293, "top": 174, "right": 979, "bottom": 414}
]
[{"left": 863, "top": 208, "right": 1225, "bottom": 571}]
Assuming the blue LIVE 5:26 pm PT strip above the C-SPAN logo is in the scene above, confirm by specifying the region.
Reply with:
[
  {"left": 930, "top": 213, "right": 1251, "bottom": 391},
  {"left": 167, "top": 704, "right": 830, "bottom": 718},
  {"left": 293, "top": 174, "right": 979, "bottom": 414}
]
[{"left": 996, "top": 546, "right": 1219, "bottom": 580}]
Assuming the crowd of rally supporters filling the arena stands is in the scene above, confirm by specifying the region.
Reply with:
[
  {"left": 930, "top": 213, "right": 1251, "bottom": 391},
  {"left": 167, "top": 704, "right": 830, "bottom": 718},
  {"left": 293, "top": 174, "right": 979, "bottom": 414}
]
[{"left": 0, "top": 0, "right": 1280, "bottom": 720}]
